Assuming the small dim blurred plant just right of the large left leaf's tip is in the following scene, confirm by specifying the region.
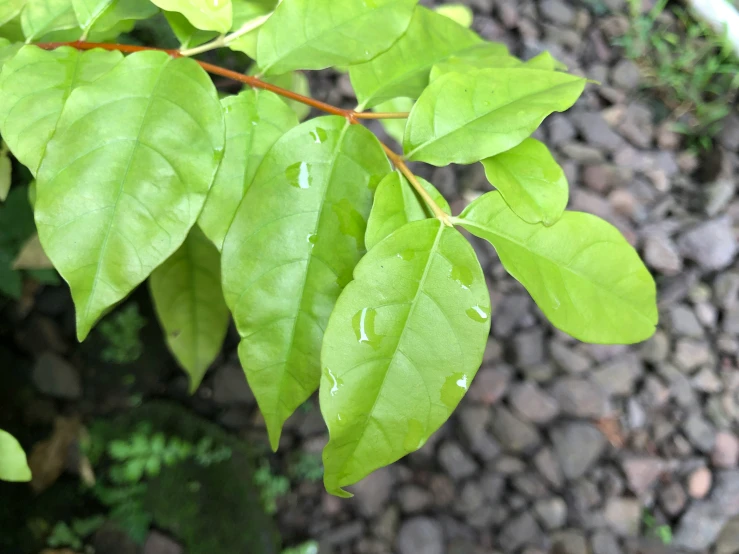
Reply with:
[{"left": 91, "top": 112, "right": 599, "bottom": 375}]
[{"left": 100, "top": 302, "right": 146, "bottom": 364}]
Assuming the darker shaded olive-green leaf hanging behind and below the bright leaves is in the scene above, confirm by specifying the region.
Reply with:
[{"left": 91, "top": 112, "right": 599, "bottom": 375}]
[{"left": 149, "top": 225, "right": 231, "bottom": 393}]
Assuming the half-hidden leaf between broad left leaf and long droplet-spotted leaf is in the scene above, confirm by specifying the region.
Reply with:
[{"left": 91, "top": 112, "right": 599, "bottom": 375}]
[{"left": 198, "top": 90, "right": 298, "bottom": 249}]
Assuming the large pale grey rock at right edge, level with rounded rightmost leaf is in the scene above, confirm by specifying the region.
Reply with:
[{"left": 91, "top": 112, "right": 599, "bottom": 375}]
[{"left": 678, "top": 217, "right": 737, "bottom": 271}]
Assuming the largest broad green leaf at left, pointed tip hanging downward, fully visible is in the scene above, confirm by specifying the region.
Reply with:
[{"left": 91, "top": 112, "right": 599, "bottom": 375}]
[{"left": 36, "top": 52, "right": 225, "bottom": 340}]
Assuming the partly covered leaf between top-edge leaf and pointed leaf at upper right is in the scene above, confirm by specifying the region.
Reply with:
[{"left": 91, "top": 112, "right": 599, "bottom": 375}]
[{"left": 349, "top": 6, "right": 481, "bottom": 109}]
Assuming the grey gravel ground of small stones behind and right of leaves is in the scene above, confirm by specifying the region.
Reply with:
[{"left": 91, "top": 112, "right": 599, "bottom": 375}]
[{"left": 262, "top": 0, "right": 739, "bottom": 554}]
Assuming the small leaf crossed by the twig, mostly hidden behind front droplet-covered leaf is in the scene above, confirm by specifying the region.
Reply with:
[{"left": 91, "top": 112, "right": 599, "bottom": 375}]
[{"left": 364, "top": 171, "right": 452, "bottom": 250}]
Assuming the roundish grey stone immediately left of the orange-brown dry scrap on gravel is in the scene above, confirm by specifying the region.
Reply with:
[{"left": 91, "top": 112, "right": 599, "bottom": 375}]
[{"left": 551, "top": 422, "right": 606, "bottom": 480}]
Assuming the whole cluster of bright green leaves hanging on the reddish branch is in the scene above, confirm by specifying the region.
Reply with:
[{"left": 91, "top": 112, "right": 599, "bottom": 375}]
[{"left": 0, "top": 0, "right": 657, "bottom": 496}]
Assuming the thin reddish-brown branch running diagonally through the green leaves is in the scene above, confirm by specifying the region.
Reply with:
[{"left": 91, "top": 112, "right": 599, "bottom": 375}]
[{"left": 36, "top": 42, "right": 453, "bottom": 221}]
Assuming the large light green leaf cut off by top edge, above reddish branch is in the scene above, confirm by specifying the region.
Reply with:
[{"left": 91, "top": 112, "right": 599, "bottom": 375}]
[{"left": 257, "top": 0, "right": 418, "bottom": 75}]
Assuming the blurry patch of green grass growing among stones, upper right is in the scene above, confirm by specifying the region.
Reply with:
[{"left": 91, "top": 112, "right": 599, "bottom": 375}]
[{"left": 618, "top": 0, "right": 739, "bottom": 149}]
